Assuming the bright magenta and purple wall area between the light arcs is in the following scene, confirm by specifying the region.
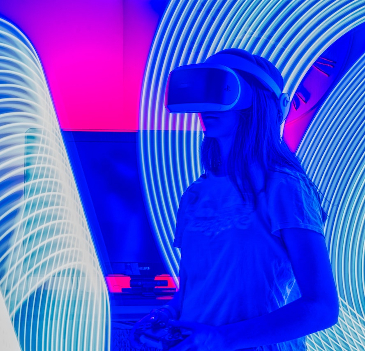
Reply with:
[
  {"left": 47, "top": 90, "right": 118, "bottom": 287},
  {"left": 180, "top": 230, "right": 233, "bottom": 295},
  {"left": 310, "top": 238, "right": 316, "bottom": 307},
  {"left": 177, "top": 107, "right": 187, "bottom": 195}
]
[{"left": 0, "top": 0, "right": 163, "bottom": 131}]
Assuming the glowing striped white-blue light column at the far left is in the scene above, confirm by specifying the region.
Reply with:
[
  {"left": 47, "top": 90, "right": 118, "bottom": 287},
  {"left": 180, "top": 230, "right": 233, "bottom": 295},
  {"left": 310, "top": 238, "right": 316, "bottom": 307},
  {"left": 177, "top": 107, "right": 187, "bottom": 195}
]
[{"left": 0, "top": 19, "right": 110, "bottom": 351}]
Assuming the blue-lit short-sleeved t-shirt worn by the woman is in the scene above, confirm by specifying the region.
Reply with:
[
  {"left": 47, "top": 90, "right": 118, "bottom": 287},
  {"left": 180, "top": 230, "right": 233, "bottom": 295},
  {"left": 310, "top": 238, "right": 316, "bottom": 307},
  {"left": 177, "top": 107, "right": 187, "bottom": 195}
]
[{"left": 173, "top": 170, "right": 325, "bottom": 351}]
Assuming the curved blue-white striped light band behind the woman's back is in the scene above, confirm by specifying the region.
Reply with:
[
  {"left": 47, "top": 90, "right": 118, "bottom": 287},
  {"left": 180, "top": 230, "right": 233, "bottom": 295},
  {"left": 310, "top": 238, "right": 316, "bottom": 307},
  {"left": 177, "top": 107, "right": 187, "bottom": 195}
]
[{"left": 297, "top": 54, "right": 365, "bottom": 350}]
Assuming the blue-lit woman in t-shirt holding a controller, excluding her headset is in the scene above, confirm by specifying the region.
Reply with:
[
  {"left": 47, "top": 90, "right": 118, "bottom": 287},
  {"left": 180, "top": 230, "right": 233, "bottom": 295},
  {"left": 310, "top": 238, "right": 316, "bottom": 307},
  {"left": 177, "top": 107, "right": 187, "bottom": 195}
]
[{"left": 129, "top": 49, "right": 339, "bottom": 351}]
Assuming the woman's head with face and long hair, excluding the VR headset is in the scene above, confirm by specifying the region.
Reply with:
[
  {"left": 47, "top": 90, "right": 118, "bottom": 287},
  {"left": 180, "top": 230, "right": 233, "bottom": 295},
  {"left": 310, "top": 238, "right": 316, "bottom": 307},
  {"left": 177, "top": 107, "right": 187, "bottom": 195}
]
[{"left": 200, "top": 49, "right": 328, "bottom": 220}]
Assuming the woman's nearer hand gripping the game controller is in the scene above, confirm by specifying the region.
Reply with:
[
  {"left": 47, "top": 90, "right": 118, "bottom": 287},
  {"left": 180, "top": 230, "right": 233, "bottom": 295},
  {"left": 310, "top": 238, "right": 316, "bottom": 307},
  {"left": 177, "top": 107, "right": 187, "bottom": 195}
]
[{"left": 168, "top": 319, "right": 231, "bottom": 351}]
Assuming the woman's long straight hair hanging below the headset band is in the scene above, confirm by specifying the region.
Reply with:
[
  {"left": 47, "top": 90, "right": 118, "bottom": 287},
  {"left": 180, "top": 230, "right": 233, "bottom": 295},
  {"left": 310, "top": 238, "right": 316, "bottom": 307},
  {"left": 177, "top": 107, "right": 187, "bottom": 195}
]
[{"left": 200, "top": 49, "right": 328, "bottom": 222}]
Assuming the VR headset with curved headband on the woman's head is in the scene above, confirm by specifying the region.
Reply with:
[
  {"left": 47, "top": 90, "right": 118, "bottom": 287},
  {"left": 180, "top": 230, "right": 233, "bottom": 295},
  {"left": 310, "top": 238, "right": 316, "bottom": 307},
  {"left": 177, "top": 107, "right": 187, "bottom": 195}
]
[{"left": 165, "top": 53, "right": 290, "bottom": 133}]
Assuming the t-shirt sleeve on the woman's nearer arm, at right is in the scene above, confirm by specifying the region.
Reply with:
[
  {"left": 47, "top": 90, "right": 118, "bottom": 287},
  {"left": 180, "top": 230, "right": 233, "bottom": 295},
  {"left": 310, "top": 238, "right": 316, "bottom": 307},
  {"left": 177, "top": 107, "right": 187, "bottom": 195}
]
[{"left": 268, "top": 173, "right": 325, "bottom": 237}]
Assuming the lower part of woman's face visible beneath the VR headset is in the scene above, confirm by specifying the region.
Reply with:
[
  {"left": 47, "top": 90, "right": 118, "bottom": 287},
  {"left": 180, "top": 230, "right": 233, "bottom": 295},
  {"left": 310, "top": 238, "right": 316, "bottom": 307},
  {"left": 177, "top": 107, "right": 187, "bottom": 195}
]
[{"left": 198, "top": 110, "right": 240, "bottom": 138}]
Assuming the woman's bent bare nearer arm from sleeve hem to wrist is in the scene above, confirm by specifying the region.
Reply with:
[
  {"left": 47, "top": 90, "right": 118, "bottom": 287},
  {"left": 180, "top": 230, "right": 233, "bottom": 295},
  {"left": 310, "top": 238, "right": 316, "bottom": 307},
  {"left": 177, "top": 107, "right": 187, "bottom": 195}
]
[{"left": 218, "top": 228, "right": 339, "bottom": 350}]
